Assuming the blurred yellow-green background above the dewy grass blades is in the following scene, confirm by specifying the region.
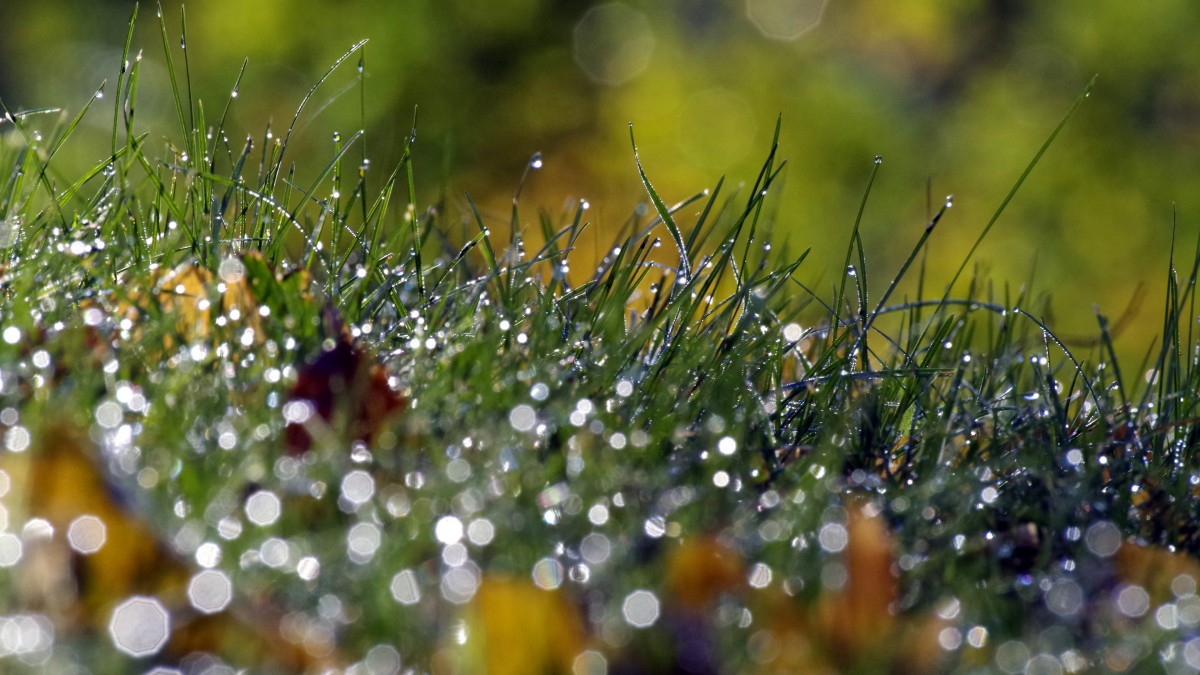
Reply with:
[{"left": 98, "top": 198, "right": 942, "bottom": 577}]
[{"left": 0, "top": 0, "right": 1200, "bottom": 356}]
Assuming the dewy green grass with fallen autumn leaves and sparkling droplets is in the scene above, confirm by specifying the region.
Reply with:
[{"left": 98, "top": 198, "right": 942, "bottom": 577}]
[{"left": 0, "top": 6, "right": 1200, "bottom": 673}]
